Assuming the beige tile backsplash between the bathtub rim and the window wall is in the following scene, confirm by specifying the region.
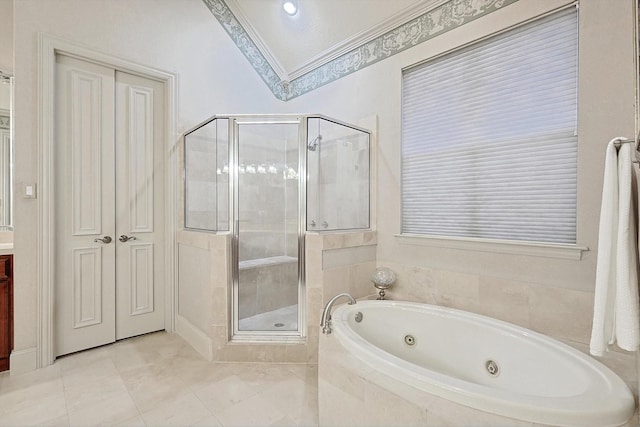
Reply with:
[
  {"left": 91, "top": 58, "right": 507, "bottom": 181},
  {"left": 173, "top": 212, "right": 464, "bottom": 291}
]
[{"left": 370, "top": 262, "right": 640, "bottom": 406}]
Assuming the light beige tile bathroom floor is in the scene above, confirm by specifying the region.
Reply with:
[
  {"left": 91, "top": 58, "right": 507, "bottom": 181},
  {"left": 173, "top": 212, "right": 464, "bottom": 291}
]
[{"left": 0, "top": 332, "right": 318, "bottom": 427}]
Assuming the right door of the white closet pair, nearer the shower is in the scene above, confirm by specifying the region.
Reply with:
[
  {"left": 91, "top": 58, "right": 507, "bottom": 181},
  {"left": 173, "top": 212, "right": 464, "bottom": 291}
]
[{"left": 116, "top": 72, "right": 165, "bottom": 339}]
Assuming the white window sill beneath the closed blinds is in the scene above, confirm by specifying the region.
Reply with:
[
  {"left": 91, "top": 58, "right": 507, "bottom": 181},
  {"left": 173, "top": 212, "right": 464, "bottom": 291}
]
[{"left": 395, "top": 234, "right": 589, "bottom": 261}]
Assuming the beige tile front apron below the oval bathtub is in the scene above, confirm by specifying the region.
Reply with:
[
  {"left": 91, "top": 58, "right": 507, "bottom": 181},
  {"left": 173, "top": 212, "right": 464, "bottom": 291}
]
[{"left": 318, "top": 335, "right": 638, "bottom": 427}]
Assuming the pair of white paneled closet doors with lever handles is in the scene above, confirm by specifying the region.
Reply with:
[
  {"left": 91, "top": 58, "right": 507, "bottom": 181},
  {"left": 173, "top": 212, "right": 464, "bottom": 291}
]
[{"left": 53, "top": 55, "right": 165, "bottom": 356}]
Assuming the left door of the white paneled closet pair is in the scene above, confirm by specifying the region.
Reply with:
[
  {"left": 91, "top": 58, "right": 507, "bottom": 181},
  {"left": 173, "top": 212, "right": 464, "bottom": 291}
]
[{"left": 53, "top": 55, "right": 115, "bottom": 356}]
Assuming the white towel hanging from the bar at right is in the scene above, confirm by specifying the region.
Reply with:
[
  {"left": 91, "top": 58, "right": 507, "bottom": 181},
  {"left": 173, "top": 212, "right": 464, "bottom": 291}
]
[{"left": 589, "top": 138, "right": 640, "bottom": 356}]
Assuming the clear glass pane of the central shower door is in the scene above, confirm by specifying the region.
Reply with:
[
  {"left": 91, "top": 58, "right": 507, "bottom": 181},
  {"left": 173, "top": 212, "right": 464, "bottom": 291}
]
[{"left": 236, "top": 122, "right": 300, "bottom": 331}]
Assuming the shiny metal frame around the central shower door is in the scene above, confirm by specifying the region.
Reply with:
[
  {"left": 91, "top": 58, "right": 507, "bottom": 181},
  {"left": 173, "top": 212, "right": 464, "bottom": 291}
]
[{"left": 230, "top": 114, "right": 308, "bottom": 343}]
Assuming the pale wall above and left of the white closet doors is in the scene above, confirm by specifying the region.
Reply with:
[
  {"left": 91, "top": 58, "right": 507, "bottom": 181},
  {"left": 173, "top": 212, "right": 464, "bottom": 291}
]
[{"left": 11, "top": 0, "right": 281, "bottom": 369}]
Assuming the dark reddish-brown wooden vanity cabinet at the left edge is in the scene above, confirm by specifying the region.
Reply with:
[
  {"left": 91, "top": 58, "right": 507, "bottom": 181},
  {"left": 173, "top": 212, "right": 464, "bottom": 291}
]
[{"left": 0, "top": 255, "right": 13, "bottom": 371}]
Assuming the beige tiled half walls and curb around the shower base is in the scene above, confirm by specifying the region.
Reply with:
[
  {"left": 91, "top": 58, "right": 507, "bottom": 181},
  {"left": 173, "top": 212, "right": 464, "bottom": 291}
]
[{"left": 176, "top": 230, "right": 377, "bottom": 364}]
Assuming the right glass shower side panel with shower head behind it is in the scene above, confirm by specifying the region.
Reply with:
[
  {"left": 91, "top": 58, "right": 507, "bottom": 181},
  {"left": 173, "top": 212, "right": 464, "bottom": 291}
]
[{"left": 307, "top": 117, "right": 370, "bottom": 231}]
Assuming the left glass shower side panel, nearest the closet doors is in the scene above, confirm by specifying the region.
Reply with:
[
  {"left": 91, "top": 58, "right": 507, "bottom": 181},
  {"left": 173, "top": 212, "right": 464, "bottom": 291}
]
[{"left": 184, "top": 119, "right": 229, "bottom": 231}]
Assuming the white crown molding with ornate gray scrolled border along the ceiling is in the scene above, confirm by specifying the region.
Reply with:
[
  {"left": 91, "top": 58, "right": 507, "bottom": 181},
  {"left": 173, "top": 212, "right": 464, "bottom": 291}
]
[{"left": 202, "top": 0, "right": 519, "bottom": 102}]
